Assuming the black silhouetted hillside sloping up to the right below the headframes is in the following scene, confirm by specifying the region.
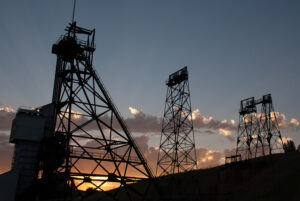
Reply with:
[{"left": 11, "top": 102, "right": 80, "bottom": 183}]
[{"left": 85, "top": 152, "right": 300, "bottom": 201}]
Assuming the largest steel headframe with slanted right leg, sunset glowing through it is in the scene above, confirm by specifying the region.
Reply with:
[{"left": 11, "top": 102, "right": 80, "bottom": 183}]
[{"left": 41, "top": 22, "right": 152, "bottom": 200}]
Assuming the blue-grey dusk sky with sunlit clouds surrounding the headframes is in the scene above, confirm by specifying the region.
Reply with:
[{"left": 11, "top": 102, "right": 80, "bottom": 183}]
[{"left": 0, "top": 0, "right": 300, "bottom": 172}]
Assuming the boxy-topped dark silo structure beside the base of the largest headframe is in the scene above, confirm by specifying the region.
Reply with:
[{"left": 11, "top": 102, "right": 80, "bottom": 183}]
[{"left": 10, "top": 108, "right": 46, "bottom": 194}]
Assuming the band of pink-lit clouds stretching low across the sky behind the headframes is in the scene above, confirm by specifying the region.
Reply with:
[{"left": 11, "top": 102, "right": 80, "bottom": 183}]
[{"left": 0, "top": 103, "right": 300, "bottom": 146}]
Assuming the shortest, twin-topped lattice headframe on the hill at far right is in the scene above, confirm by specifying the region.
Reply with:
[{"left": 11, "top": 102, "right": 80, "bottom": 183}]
[{"left": 236, "top": 94, "right": 283, "bottom": 159}]
